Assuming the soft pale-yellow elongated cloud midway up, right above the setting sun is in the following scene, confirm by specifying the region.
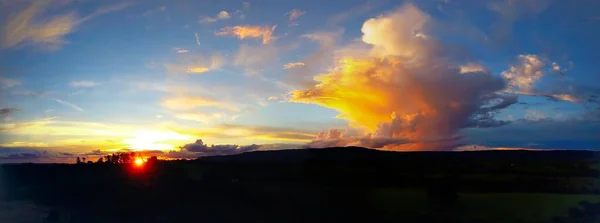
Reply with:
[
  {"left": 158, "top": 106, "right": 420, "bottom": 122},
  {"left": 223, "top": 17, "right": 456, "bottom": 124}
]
[{"left": 161, "top": 95, "right": 240, "bottom": 112}]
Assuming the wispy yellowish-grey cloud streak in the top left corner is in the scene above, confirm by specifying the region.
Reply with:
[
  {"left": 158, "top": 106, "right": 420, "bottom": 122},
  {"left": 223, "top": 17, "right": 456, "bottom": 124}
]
[{"left": 0, "top": 1, "right": 128, "bottom": 50}]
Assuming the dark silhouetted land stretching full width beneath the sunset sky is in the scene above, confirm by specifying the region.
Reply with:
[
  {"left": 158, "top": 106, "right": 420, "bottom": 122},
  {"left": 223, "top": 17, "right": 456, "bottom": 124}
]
[{"left": 0, "top": 148, "right": 600, "bottom": 222}]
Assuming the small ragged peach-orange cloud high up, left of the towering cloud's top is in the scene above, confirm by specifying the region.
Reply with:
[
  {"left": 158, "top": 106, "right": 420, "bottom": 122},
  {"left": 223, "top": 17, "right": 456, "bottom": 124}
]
[{"left": 215, "top": 26, "right": 277, "bottom": 44}]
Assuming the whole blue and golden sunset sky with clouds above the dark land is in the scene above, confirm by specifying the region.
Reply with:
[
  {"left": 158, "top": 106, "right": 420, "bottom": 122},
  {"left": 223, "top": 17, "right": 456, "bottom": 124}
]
[{"left": 0, "top": 0, "right": 600, "bottom": 162}]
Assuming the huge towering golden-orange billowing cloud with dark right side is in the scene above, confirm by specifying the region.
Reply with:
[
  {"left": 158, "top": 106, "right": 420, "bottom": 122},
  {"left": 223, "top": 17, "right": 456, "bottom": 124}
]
[{"left": 290, "top": 4, "right": 516, "bottom": 149}]
